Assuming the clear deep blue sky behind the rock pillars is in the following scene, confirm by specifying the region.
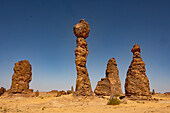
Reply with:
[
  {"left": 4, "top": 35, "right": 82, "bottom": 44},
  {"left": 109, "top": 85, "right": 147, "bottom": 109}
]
[{"left": 0, "top": 0, "right": 170, "bottom": 92}]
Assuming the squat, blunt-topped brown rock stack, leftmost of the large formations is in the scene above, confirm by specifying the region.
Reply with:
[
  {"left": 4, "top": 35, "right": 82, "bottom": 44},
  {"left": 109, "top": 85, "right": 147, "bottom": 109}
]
[{"left": 3, "top": 60, "right": 34, "bottom": 96}]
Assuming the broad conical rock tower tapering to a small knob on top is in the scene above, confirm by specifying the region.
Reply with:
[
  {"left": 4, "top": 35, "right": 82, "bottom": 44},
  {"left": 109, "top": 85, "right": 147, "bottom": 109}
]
[{"left": 125, "top": 44, "right": 151, "bottom": 100}]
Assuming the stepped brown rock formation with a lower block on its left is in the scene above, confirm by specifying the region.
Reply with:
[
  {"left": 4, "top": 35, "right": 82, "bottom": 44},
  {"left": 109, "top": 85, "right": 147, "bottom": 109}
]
[{"left": 94, "top": 58, "right": 122, "bottom": 96}]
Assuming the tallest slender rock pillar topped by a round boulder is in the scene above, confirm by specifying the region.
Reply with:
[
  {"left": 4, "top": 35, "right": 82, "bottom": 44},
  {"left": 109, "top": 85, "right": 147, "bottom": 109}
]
[{"left": 73, "top": 19, "right": 93, "bottom": 96}]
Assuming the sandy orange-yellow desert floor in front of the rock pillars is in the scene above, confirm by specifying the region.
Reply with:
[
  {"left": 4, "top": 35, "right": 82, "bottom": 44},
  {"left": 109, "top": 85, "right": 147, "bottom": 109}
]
[{"left": 0, "top": 93, "right": 170, "bottom": 113}]
